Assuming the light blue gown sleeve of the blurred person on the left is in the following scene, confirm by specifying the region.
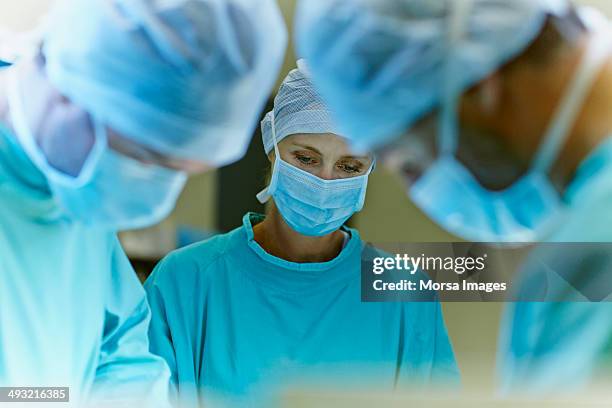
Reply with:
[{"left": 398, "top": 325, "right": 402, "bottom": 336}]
[{"left": 92, "top": 236, "right": 169, "bottom": 408}]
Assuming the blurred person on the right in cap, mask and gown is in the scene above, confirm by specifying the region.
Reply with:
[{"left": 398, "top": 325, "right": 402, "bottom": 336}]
[{"left": 297, "top": 0, "right": 612, "bottom": 393}]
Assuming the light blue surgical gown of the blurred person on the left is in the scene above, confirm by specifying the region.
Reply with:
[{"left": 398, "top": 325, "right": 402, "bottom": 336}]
[{"left": 0, "top": 121, "right": 169, "bottom": 407}]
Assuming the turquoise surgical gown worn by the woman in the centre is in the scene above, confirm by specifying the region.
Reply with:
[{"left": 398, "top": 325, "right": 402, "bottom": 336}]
[{"left": 145, "top": 214, "right": 458, "bottom": 407}]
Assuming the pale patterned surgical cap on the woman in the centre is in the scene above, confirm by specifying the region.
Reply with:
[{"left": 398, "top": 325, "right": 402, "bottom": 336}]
[{"left": 261, "top": 60, "right": 338, "bottom": 154}]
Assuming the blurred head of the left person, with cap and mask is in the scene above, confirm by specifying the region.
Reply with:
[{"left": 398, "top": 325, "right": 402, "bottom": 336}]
[{"left": 9, "top": 0, "right": 286, "bottom": 230}]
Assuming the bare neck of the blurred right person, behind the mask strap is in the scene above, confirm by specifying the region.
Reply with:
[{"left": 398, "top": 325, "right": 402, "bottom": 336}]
[{"left": 552, "top": 47, "right": 612, "bottom": 190}]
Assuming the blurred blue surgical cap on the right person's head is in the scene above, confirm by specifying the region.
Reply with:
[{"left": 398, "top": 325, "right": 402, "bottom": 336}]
[{"left": 297, "top": 0, "right": 568, "bottom": 149}]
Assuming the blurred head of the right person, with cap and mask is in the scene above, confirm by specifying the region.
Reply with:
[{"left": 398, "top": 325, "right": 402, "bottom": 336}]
[{"left": 297, "top": 0, "right": 610, "bottom": 242}]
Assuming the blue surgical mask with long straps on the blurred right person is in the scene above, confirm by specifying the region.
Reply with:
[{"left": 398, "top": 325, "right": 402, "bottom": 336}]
[{"left": 409, "top": 5, "right": 609, "bottom": 243}]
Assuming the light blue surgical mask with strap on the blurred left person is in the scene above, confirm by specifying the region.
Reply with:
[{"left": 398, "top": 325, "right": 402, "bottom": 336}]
[{"left": 8, "top": 71, "right": 187, "bottom": 230}]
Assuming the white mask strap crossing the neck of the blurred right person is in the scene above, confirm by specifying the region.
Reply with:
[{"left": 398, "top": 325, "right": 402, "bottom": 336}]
[{"left": 532, "top": 33, "right": 610, "bottom": 173}]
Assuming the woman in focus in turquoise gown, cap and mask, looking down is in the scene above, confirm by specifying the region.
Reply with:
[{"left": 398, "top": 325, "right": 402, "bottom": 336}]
[{"left": 145, "top": 61, "right": 457, "bottom": 407}]
